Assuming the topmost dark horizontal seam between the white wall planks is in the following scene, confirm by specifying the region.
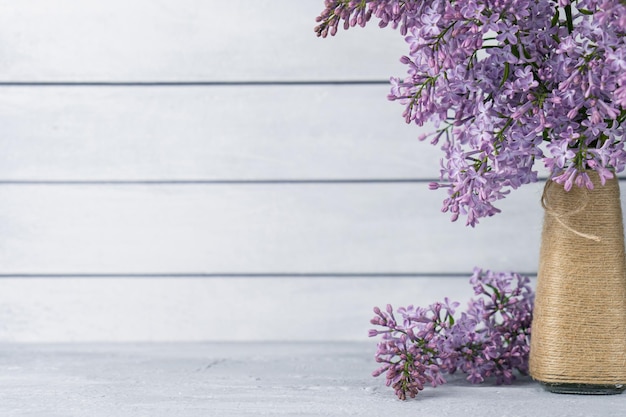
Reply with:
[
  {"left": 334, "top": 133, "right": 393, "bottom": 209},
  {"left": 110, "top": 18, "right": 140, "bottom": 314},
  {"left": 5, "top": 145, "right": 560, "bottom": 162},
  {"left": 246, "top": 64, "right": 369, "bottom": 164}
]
[{"left": 0, "top": 80, "right": 389, "bottom": 87}]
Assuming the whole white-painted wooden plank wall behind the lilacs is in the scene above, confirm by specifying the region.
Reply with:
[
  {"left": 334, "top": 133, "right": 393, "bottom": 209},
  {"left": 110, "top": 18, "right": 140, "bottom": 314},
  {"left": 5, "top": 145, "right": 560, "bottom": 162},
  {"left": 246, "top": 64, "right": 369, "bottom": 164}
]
[{"left": 0, "top": 0, "right": 584, "bottom": 342}]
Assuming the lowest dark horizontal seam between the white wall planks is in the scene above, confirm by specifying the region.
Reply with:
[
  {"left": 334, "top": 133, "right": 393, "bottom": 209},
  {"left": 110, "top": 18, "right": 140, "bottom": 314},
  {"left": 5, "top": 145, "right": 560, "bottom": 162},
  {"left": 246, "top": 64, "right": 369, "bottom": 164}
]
[{"left": 0, "top": 272, "right": 537, "bottom": 279}]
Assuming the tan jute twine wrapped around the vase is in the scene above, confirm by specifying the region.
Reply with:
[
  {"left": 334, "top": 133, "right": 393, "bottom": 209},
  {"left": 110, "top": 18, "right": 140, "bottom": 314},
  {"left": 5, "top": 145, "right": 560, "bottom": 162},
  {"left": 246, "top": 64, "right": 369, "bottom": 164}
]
[{"left": 530, "top": 172, "right": 626, "bottom": 385}]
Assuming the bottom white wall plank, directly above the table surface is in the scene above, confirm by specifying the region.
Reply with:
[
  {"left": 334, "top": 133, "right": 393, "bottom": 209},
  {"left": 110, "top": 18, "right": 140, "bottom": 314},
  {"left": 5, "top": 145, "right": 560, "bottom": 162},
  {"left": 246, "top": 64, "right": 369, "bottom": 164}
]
[{"left": 0, "top": 274, "right": 480, "bottom": 343}]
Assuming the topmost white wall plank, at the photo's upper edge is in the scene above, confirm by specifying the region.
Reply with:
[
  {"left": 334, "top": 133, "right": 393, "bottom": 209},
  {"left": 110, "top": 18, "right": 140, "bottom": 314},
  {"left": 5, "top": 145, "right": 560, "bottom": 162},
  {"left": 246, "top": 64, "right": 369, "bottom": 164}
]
[{"left": 0, "top": 0, "right": 406, "bottom": 82}]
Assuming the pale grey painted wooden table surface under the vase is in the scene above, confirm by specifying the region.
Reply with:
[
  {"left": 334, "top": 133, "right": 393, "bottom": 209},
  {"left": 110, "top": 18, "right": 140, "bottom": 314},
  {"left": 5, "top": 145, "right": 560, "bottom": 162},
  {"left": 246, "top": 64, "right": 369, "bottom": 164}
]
[{"left": 0, "top": 342, "right": 626, "bottom": 417}]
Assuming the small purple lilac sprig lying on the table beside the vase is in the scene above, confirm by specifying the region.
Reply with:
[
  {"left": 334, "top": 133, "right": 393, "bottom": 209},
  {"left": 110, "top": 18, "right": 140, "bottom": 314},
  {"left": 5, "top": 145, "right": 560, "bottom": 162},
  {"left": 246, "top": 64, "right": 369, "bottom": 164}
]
[{"left": 369, "top": 268, "right": 534, "bottom": 400}]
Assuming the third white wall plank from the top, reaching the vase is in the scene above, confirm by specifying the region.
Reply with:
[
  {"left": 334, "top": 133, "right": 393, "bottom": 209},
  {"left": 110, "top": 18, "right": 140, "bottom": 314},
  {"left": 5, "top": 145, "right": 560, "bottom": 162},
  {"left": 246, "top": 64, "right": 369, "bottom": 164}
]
[{"left": 0, "top": 183, "right": 541, "bottom": 274}]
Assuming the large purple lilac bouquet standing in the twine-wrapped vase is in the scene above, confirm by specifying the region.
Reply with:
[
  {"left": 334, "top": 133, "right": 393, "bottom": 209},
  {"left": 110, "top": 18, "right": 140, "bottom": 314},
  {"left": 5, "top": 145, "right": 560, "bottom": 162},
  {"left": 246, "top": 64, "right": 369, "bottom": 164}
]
[{"left": 315, "top": 0, "right": 626, "bottom": 226}]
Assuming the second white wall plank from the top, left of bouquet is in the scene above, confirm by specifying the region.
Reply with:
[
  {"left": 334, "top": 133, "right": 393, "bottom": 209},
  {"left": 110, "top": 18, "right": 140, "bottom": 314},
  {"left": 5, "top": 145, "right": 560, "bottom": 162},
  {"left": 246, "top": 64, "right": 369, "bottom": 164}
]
[{"left": 0, "top": 85, "right": 442, "bottom": 180}]
